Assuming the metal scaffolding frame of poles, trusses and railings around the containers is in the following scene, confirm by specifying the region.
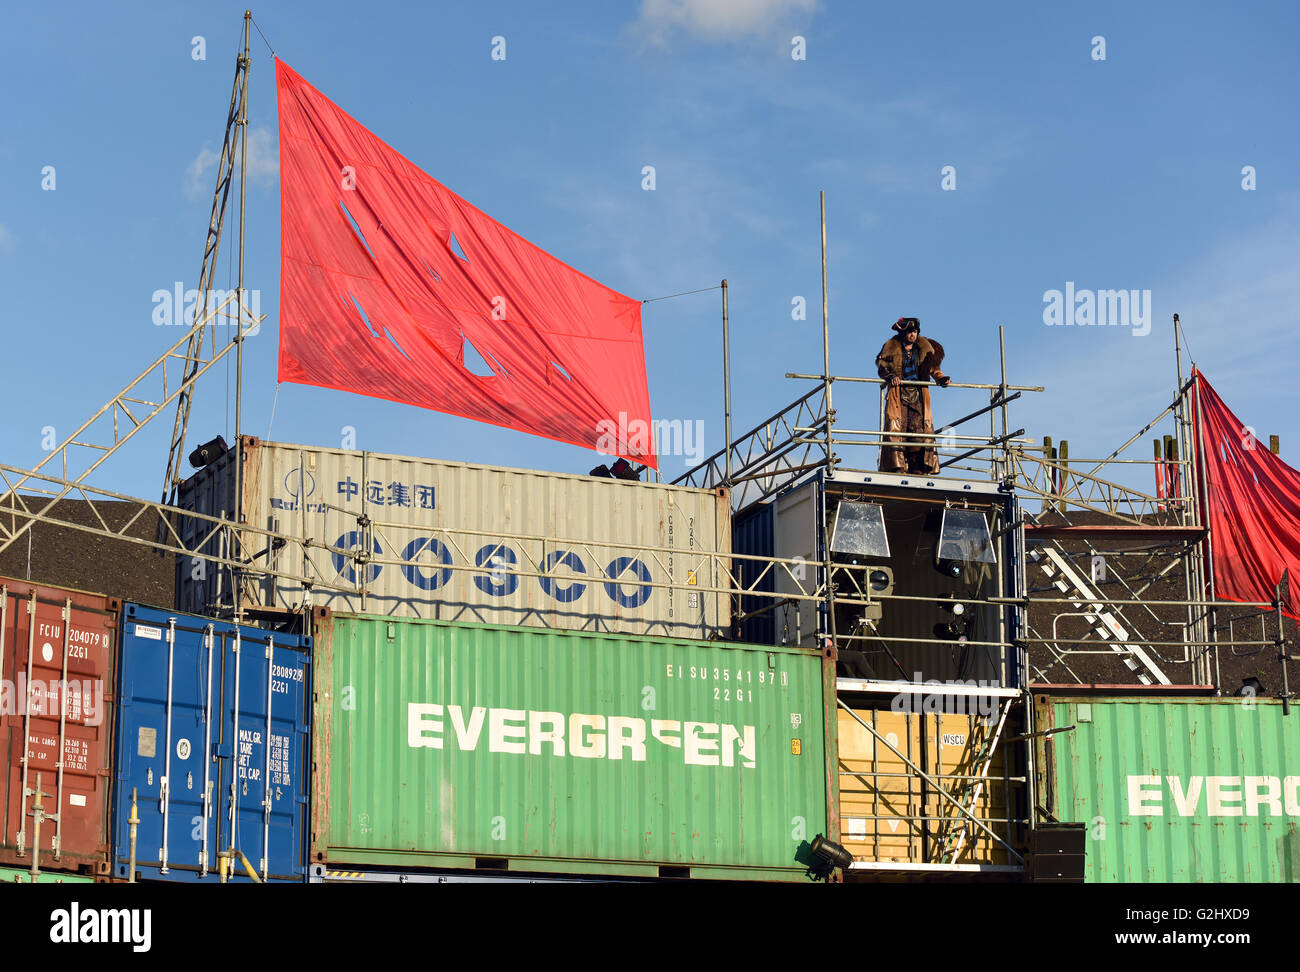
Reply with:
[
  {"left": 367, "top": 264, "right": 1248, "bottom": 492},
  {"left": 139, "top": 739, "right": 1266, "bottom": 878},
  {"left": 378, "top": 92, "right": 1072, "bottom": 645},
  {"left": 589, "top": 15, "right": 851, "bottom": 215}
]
[{"left": 0, "top": 47, "right": 1286, "bottom": 873}]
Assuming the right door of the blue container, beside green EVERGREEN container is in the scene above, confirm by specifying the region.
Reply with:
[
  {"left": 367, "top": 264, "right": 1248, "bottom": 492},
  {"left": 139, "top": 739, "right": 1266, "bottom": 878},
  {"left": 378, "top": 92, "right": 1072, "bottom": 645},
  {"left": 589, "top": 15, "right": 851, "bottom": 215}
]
[{"left": 220, "top": 628, "right": 311, "bottom": 881}]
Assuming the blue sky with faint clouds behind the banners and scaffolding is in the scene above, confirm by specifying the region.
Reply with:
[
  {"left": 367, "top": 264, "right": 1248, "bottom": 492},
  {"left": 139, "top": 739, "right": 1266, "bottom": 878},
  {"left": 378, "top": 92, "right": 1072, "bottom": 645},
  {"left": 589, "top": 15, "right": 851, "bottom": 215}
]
[{"left": 0, "top": 0, "right": 1300, "bottom": 498}]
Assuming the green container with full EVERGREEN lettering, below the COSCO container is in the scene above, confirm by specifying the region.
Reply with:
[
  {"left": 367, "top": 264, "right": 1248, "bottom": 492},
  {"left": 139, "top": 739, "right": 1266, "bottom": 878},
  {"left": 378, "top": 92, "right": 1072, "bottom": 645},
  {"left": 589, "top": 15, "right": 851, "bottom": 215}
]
[{"left": 311, "top": 611, "right": 839, "bottom": 880}]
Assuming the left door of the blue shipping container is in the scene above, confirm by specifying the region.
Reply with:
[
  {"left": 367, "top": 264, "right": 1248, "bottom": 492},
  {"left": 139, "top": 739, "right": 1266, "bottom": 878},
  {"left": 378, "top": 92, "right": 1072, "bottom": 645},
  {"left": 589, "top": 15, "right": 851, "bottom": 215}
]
[{"left": 113, "top": 615, "right": 217, "bottom": 881}]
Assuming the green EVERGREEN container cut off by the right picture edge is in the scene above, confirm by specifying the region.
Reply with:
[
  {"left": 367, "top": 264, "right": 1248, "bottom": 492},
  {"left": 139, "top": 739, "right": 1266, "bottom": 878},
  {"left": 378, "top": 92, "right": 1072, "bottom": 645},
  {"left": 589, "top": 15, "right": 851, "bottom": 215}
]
[{"left": 1035, "top": 695, "right": 1300, "bottom": 884}]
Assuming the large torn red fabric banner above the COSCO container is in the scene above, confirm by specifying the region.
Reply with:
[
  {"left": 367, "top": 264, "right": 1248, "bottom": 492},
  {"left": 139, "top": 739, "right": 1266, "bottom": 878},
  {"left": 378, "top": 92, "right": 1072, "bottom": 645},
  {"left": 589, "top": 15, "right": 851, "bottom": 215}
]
[{"left": 276, "top": 60, "right": 657, "bottom": 467}]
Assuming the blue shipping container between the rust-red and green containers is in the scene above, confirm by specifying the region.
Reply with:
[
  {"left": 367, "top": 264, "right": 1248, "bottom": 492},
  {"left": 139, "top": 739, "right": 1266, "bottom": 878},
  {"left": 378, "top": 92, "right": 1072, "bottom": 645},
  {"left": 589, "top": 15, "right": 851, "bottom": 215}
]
[{"left": 113, "top": 604, "right": 312, "bottom": 884}]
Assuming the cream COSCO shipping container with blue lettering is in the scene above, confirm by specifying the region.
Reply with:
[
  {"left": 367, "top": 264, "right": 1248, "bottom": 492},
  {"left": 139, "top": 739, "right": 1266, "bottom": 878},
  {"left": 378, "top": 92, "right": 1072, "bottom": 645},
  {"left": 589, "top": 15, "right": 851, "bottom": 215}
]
[{"left": 177, "top": 437, "right": 731, "bottom": 638}]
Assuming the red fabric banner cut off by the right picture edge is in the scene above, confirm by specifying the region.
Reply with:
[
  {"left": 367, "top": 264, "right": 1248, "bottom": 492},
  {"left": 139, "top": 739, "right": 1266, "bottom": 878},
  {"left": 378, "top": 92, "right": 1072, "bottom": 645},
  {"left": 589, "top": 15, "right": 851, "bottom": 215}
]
[{"left": 1193, "top": 370, "right": 1300, "bottom": 617}]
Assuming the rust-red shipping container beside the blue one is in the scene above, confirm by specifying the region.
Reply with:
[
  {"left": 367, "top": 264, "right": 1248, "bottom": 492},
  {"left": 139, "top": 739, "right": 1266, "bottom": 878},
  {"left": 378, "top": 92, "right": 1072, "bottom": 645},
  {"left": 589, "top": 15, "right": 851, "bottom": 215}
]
[{"left": 0, "top": 577, "right": 121, "bottom": 875}]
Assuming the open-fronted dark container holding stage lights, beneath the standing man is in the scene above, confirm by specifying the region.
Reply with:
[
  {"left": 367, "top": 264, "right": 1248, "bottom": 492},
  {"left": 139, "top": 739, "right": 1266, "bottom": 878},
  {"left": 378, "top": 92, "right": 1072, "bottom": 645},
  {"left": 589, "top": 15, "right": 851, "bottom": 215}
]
[{"left": 733, "top": 470, "right": 1023, "bottom": 686}]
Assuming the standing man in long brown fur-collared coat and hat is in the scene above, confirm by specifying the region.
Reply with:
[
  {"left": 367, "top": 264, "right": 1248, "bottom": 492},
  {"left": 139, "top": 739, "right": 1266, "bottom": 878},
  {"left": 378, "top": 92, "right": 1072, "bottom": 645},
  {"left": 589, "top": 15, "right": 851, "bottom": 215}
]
[{"left": 876, "top": 317, "right": 952, "bottom": 476}]
